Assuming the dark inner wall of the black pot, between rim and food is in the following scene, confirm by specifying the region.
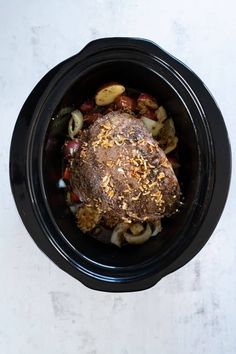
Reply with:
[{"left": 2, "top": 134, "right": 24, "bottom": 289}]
[{"left": 42, "top": 60, "right": 199, "bottom": 267}]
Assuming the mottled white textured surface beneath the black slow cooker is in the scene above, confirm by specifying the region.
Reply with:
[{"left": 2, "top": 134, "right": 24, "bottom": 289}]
[{"left": 0, "top": 0, "right": 236, "bottom": 354}]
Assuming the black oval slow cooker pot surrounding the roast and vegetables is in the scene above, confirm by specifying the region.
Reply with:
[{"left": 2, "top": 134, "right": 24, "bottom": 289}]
[{"left": 10, "top": 38, "right": 231, "bottom": 292}]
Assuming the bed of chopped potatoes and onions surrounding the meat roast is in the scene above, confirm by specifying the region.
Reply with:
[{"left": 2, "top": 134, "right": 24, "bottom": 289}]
[{"left": 60, "top": 82, "right": 180, "bottom": 247}]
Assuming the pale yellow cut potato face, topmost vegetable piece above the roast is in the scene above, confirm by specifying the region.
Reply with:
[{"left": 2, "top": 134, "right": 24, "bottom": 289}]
[{"left": 95, "top": 83, "right": 125, "bottom": 106}]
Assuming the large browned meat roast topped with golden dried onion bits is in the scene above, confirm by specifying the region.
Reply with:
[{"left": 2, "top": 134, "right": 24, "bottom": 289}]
[{"left": 71, "top": 111, "right": 180, "bottom": 226}]
